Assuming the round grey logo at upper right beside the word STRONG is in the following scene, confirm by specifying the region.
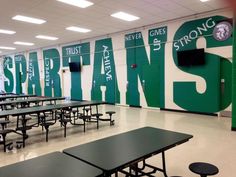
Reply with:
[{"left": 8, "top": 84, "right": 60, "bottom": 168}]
[{"left": 213, "top": 21, "right": 232, "bottom": 41}]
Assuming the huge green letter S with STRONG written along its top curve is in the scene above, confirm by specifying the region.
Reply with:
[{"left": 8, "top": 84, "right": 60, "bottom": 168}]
[{"left": 173, "top": 16, "right": 232, "bottom": 113}]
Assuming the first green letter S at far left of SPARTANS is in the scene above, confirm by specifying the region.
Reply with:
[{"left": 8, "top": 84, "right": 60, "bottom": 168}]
[{"left": 3, "top": 57, "right": 14, "bottom": 92}]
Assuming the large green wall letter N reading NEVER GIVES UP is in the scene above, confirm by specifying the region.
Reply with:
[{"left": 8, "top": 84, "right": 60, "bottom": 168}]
[{"left": 125, "top": 27, "right": 167, "bottom": 108}]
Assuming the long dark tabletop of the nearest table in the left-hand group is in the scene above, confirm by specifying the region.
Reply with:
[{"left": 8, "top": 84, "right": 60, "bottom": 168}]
[{"left": 0, "top": 101, "right": 105, "bottom": 118}]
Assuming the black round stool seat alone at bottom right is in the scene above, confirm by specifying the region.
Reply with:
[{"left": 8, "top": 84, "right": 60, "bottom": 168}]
[{"left": 189, "top": 162, "right": 219, "bottom": 177}]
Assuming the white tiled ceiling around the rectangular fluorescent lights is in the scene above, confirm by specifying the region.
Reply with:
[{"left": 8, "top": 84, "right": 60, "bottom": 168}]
[{"left": 0, "top": 0, "right": 229, "bottom": 55}]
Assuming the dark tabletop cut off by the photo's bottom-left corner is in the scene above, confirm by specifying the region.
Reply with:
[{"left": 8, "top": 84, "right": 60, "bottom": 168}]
[{"left": 0, "top": 152, "right": 102, "bottom": 177}]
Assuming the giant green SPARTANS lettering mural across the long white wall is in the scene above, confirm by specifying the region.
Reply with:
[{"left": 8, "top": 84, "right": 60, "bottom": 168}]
[{"left": 0, "top": 13, "right": 232, "bottom": 113}]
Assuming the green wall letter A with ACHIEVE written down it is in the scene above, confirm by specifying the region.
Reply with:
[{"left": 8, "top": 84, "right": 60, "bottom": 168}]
[{"left": 91, "top": 38, "right": 120, "bottom": 103}]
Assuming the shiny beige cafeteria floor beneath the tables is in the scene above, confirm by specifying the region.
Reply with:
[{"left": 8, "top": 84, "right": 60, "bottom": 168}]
[{"left": 0, "top": 106, "right": 236, "bottom": 177}]
